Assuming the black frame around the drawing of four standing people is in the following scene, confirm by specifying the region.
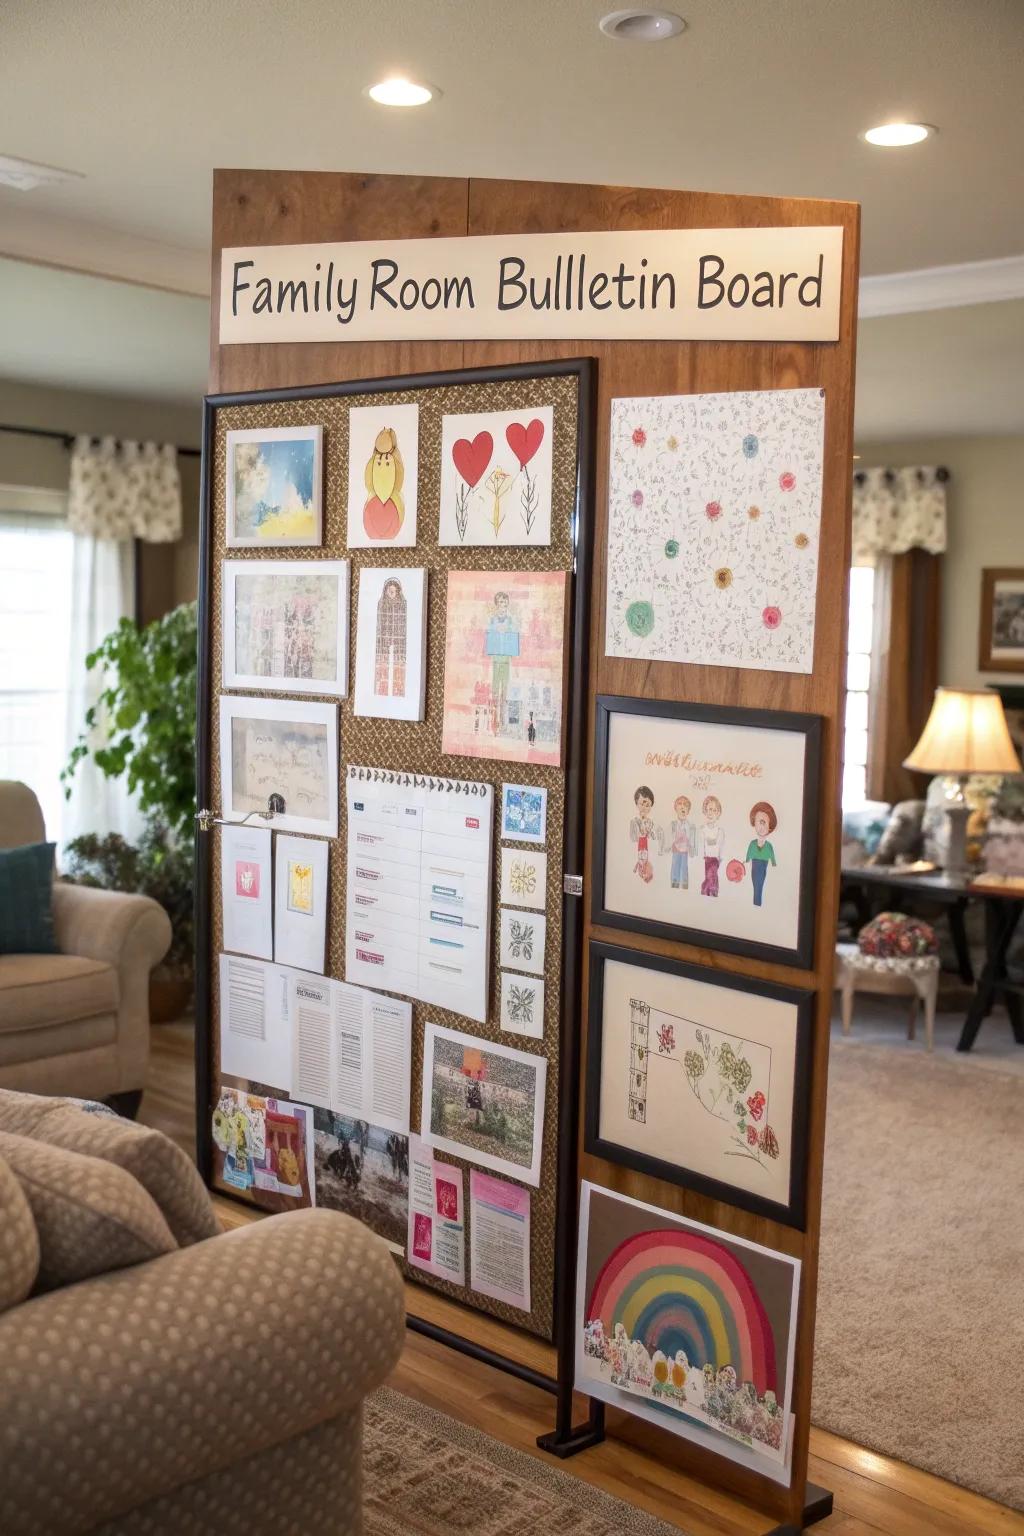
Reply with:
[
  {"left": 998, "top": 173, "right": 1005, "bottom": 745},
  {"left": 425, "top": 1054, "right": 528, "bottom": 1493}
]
[{"left": 591, "top": 694, "right": 821, "bottom": 971}]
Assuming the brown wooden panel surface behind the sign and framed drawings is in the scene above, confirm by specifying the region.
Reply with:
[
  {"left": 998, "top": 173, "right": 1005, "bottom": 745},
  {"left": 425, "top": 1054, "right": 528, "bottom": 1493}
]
[{"left": 210, "top": 170, "right": 860, "bottom": 1530}]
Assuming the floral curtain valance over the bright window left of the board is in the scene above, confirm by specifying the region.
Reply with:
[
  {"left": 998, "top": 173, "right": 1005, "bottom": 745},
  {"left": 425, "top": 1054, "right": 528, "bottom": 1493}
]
[{"left": 68, "top": 438, "right": 181, "bottom": 544}]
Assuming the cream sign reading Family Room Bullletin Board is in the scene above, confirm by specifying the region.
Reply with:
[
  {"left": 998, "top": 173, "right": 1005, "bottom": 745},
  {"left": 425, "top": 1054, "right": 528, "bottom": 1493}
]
[{"left": 220, "top": 226, "right": 843, "bottom": 346}]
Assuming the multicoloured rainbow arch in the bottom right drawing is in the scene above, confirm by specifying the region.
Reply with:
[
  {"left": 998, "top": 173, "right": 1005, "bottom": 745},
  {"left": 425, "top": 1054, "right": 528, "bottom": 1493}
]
[{"left": 586, "top": 1227, "right": 778, "bottom": 1398}]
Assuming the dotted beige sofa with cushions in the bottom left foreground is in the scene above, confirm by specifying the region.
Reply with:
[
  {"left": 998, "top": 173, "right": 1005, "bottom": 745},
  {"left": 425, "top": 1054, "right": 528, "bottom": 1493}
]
[{"left": 0, "top": 1092, "right": 405, "bottom": 1536}]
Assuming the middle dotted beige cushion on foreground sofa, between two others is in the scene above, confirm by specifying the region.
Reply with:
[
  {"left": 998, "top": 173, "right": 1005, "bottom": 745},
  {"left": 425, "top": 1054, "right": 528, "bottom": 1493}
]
[{"left": 0, "top": 1130, "right": 178, "bottom": 1292}]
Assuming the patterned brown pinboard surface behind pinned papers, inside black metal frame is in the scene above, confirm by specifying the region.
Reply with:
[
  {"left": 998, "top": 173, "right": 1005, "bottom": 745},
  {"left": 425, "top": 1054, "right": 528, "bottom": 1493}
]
[{"left": 198, "top": 361, "right": 593, "bottom": 1339}]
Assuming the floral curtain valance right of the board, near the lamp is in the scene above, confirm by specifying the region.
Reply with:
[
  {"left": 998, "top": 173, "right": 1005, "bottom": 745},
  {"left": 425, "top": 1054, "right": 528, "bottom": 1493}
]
[{"left": 854, "top": 467, "right": 949, "bottom": 562}]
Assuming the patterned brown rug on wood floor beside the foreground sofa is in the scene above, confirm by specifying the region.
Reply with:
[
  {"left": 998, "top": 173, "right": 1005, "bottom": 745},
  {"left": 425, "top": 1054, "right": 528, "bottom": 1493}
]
[{"left": 362, "top": 1387, "right": 680, "bottom": 1536}]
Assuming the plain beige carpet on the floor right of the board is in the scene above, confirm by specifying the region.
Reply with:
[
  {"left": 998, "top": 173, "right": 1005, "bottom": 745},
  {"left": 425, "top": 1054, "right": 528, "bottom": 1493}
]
[{"left": 812, "top": 1040, "right": 1024, "bottom": 1508}]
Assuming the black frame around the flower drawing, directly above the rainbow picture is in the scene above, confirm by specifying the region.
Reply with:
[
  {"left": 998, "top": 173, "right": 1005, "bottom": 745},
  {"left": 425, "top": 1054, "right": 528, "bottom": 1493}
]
[{"left": 583, "top": 938, "right": 815, "bottom": 1232}]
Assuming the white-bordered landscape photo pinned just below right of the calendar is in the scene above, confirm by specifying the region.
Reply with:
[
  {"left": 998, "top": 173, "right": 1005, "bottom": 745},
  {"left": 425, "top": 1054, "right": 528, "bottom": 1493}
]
[{"left": 419, "top": 1025, "right": 548, "bottom": 1189}]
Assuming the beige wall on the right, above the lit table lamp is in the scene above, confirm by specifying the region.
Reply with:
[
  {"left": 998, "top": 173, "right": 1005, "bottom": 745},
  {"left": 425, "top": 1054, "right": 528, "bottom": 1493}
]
[{"left": 857, "top": 438, "right": 1024, "bottom": 688}]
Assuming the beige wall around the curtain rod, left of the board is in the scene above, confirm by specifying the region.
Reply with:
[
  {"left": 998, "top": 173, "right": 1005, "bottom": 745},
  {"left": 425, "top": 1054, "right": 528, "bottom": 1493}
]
[{"left": 0, "top": 379, "right": 203, "bottom": 621}]
